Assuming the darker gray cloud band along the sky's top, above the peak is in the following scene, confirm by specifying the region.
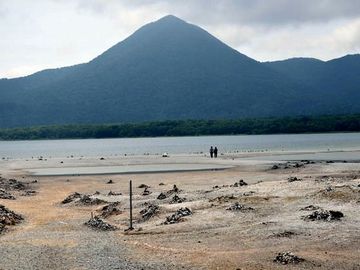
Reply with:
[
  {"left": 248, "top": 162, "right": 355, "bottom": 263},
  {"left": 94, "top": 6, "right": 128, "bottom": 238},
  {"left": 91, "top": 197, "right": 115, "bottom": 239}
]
[{"left": 79, "top": 0, "right": 360, "bottom": 24}]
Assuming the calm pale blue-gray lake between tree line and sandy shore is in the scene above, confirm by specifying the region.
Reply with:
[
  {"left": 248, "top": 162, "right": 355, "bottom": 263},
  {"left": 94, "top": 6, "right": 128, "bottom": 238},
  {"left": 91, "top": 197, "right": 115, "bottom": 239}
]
[{"left": 0, "top": 133, "right": 360, "bottom": 158}]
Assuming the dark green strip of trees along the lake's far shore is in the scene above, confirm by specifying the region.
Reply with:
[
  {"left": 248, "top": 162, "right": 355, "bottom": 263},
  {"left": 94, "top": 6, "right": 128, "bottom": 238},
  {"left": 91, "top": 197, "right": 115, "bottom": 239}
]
[{"left": 0, "top": 114, "right": 360, "bottom": 140}]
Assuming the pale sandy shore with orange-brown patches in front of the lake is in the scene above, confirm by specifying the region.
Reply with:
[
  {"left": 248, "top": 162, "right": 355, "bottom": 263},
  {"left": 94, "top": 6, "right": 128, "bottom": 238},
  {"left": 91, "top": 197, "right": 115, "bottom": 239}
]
[{"left": 0, "top": 152, "right": 360, "bottom": 270}]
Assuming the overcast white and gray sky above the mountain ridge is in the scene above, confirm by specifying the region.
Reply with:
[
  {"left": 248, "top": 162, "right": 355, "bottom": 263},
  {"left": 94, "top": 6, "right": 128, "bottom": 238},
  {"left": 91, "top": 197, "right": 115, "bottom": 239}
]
[{"left": 0, "top": 0, "right": 360, "bottom": 78}]
